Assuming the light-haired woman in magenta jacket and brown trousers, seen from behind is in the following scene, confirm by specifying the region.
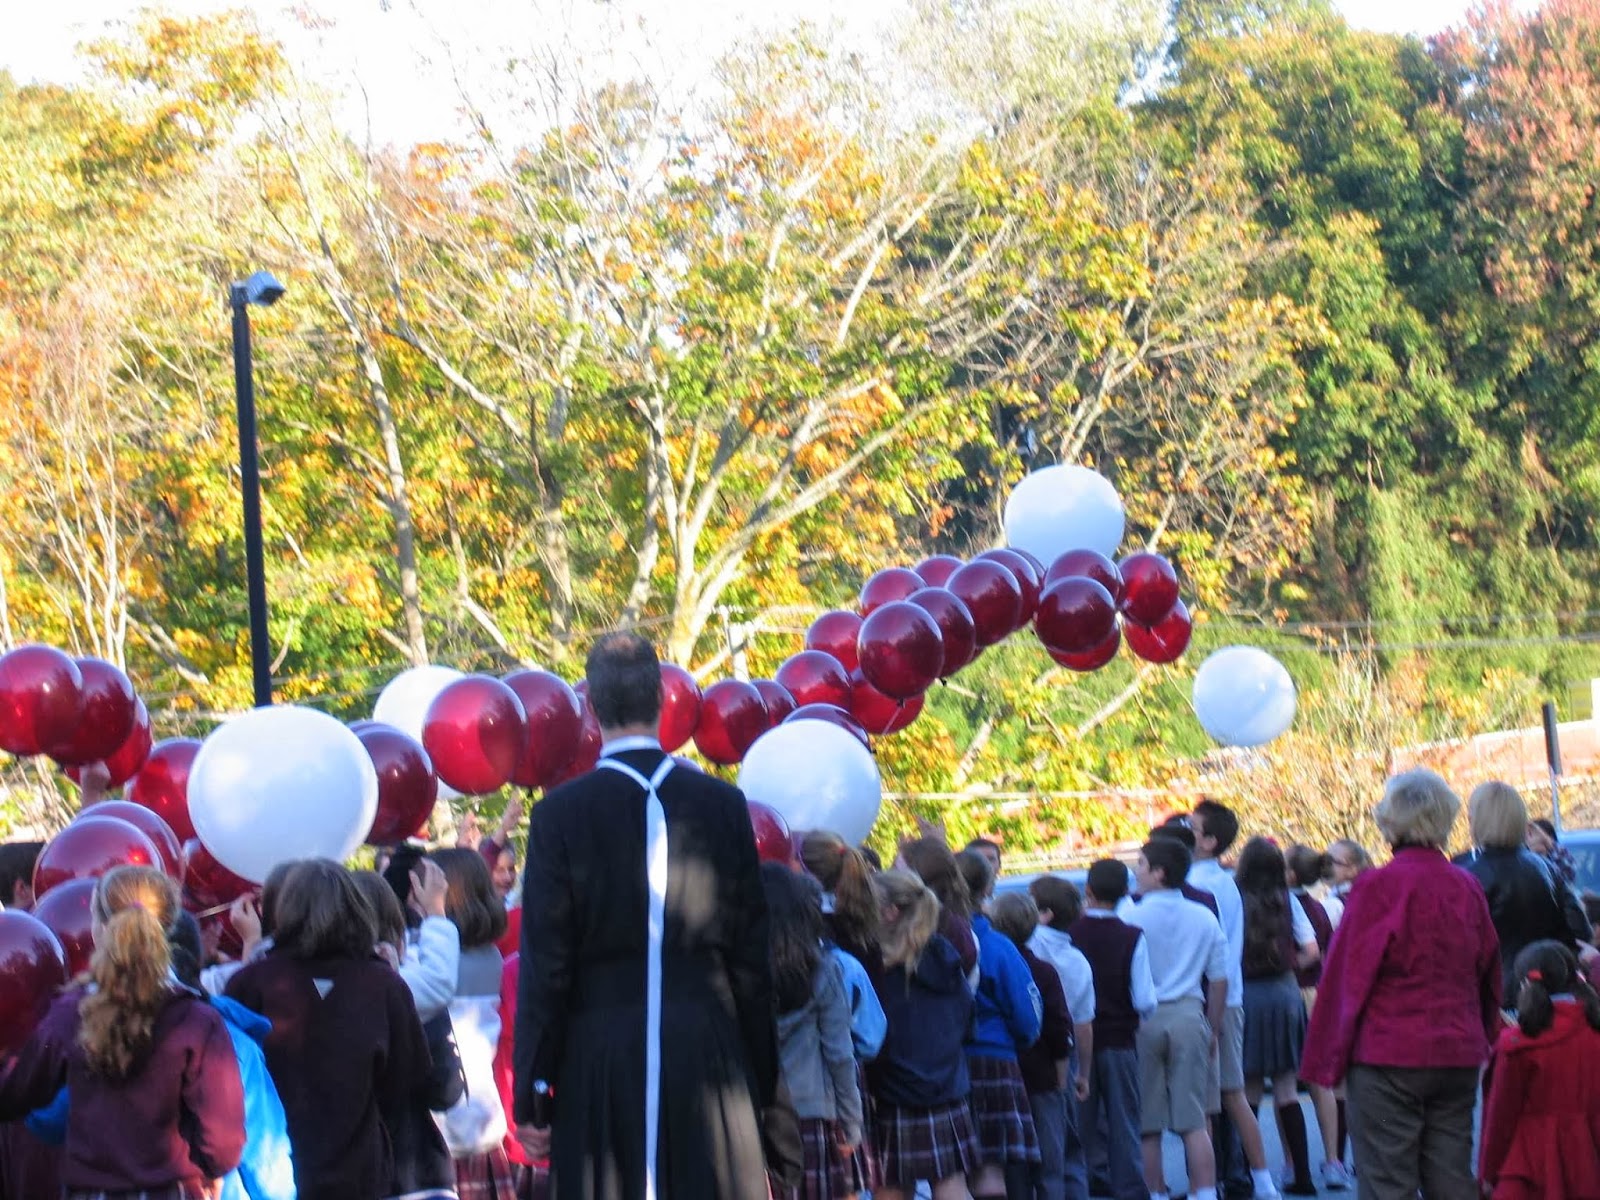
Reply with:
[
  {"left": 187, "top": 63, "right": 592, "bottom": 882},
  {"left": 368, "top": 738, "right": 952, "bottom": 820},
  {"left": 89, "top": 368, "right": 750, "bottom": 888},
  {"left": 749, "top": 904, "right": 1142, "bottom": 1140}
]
[{"left": 1301, "top": 770, "right": 1501, "bottom": 1200}]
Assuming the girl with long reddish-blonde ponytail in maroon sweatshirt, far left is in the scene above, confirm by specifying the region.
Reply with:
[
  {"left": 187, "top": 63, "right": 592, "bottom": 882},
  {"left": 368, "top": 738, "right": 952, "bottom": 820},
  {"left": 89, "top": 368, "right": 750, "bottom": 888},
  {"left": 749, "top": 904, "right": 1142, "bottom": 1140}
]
[{"left": 0, "top": 867, "right": 245, "bottom": 1200}]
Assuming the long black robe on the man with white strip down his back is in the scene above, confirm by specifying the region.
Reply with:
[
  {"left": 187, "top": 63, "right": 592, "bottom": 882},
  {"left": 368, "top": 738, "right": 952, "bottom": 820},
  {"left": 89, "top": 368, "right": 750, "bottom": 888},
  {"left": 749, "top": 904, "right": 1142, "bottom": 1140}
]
[{"left": 514, "top": 749, "right": 778, "bottom": 1200}]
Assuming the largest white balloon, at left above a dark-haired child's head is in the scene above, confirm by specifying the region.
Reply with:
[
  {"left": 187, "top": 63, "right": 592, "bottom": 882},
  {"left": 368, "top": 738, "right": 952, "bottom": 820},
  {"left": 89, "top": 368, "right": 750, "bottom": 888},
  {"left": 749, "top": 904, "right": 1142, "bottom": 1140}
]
[{"left": 189, "top": 706, "right": 378, "bottom": 883}]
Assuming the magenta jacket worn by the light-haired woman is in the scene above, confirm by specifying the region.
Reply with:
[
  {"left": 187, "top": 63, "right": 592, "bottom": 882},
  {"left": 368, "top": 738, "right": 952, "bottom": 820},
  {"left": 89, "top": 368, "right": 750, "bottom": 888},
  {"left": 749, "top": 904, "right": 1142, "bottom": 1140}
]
[{"left": 1301, "top": 846, "right": 1502, "bottom": 1088}]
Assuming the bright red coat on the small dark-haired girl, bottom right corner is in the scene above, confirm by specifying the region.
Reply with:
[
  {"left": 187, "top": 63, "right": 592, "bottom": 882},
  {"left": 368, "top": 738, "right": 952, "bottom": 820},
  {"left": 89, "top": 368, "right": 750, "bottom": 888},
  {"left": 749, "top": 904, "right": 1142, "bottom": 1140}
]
[{"left": 1478, "top": 1002, "right": 1600, "bottom": 1200}]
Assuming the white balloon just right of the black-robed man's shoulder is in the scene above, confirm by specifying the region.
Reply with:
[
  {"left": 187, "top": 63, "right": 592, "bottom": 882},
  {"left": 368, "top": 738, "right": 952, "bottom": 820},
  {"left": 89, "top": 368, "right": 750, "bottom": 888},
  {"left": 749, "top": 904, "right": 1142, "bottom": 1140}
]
[{"left": 739, "top": 720, "right": 883, "bottom": 845}]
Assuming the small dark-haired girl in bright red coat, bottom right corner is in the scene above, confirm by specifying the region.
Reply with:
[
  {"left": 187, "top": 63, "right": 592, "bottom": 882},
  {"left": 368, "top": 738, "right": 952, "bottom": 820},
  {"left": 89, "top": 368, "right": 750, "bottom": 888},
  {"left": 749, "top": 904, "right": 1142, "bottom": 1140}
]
[{"left": 1478, "top": 941, "right": 1600, "bottom": 1200}]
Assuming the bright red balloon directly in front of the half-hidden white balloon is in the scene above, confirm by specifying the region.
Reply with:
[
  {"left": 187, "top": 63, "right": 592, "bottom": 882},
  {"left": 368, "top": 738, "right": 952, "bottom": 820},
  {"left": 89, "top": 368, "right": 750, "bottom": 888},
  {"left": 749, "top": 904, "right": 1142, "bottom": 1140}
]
[{"left": 422, "top": 675, "right": 528, "bottom": 795}]
